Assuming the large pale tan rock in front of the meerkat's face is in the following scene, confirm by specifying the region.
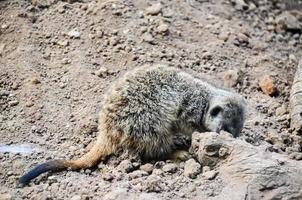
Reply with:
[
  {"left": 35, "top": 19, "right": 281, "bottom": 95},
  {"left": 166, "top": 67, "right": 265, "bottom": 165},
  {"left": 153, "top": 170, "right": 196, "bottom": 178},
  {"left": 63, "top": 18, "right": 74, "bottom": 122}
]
[{"left": 190, "top": 132, "right": 302, "bottom": 200}]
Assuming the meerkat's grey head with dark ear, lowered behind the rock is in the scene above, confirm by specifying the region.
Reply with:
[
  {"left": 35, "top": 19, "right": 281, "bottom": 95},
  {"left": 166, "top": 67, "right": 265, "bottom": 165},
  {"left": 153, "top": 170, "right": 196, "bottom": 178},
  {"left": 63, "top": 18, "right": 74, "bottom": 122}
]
[{"left": 203, "top": 94, "right": 245, "bottom": 137}]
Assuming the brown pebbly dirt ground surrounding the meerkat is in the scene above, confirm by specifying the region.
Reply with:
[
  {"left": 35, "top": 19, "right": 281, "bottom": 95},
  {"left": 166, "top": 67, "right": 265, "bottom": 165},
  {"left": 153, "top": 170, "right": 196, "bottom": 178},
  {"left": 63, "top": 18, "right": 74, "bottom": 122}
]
[{"left": 0, "top": 0, "right": 302, "bottom": 200}]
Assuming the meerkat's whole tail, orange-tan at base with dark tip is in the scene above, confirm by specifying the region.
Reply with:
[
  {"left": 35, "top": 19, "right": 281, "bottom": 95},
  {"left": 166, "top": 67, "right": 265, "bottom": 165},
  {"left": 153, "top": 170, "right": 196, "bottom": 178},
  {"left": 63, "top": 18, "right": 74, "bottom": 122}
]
[{"left": 19, "top": 143, "right": 112, "bottom": 185}]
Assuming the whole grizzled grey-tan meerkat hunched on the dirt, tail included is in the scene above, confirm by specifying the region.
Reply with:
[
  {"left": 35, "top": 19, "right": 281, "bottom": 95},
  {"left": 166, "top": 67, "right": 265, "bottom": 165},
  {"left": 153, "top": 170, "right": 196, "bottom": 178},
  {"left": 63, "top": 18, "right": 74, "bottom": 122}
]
[{"left": 19, "top": 66, "right": 245, "bottom": 184}]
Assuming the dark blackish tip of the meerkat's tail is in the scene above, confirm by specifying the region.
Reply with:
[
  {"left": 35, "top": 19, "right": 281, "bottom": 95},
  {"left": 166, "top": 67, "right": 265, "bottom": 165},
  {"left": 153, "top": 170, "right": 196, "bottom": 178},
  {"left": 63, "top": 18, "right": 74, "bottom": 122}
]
[{"left": 19, "top": 160, "right": 67, "bottom": 185}]
